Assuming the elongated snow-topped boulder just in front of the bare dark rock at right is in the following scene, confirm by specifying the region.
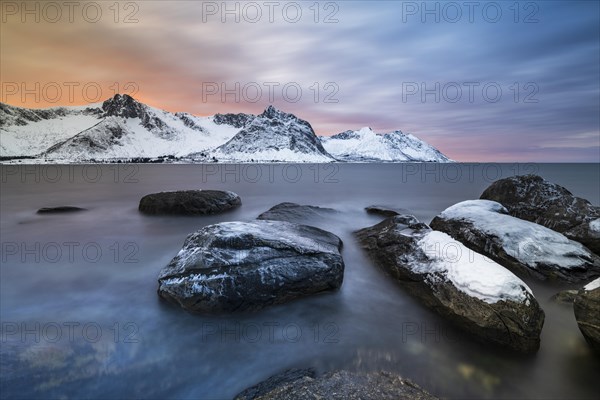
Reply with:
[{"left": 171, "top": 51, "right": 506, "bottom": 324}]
[{"left": 431, "top": 200, "right": 600, "bottom": 282}]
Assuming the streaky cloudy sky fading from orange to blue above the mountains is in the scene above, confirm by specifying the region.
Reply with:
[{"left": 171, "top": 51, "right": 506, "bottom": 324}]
[{"left": 0, "top": 0, "right": 600, "bottom": 162}]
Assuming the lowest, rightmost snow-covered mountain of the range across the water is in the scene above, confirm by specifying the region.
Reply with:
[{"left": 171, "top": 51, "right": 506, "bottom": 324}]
[{"left": 321, "top": 128, "right": 452, "bottom": 162}]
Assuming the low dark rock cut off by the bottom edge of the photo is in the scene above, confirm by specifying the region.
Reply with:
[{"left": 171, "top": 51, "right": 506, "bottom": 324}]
[{"left": 235, "top": 370, "right": 436, "bottom": 400}]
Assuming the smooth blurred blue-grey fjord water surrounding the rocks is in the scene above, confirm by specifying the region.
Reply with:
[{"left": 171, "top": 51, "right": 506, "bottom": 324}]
[{"left": 0, "top": 164, "right": 600, "bottom": 399}]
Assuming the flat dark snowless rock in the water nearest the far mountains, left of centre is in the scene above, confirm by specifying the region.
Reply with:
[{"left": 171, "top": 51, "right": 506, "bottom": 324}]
[{"left": 139, "top": 190, "right": 242, "bottom": 215}]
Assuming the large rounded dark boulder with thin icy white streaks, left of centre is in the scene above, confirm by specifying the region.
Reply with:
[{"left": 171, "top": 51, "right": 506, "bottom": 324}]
[{"left": 158, "top": 220, "right": 344, "bottom": 313}]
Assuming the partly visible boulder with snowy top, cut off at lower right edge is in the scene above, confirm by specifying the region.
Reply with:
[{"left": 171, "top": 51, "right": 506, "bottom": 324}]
[{"left": 573, "top": 278, "right": 600, "bottom": 352}]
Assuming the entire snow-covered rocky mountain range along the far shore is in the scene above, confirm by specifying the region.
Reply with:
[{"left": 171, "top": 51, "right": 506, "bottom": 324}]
[{"left": 0, "top": 95, "right": 449, "bottom": 163}]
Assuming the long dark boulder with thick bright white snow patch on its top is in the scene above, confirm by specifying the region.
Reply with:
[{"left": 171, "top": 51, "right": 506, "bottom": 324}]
[{"left": 356, "top": 215, "right": 544, "bottom": 352}]
